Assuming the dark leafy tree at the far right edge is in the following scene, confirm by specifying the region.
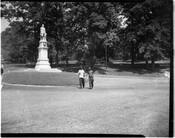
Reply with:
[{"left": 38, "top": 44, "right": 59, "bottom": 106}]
[{"left": 132, "top": 0, "right": 172, "bottom": 70}]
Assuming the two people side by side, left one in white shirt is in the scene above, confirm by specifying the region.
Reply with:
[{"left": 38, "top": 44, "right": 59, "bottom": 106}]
[{"left": 78, "top": 67, "right": 94, "bottom": 89}]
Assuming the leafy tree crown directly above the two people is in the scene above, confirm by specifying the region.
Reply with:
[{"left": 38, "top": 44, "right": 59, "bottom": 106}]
[{"left": 71, "top": 2, "right": 121, "bottom": 67}]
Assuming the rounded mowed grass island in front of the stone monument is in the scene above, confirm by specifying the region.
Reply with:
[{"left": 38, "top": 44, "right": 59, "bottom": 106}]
[{"left": 2, "top": 71, "right": 79, "bottom": 86}]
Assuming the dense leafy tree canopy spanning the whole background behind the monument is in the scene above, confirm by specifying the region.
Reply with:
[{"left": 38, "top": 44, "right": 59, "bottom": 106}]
[{"left": 1, "top": 0, "right": 172, "bottom": 69}]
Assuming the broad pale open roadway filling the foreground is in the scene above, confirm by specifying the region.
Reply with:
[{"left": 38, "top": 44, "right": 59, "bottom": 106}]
[{"left": 1, "top": 76, "right": 169, "bottom": 137}]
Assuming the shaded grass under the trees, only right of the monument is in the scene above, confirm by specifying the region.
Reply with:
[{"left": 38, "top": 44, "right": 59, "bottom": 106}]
[{"left": 55, "top": 63, "right": 169, "bottom": 75}]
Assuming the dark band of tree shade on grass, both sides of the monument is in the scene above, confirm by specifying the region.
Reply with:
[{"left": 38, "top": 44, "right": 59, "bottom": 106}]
[{"left": 3, "top": 60, "right": 170, "bottom": 75}]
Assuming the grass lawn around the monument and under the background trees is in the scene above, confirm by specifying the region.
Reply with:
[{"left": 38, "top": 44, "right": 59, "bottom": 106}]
[{"left": 2, "top": 61, "right": 169, "bottom": 86}]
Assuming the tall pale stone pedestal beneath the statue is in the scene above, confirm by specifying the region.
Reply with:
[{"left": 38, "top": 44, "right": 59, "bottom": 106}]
[{"left": 35, "top": 39, "right": 51, "bottom": 70}]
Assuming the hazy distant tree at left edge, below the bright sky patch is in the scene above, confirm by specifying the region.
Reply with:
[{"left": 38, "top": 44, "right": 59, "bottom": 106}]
[{"left": 1, "top": 22, "right": 26, "bottom": 62}]
